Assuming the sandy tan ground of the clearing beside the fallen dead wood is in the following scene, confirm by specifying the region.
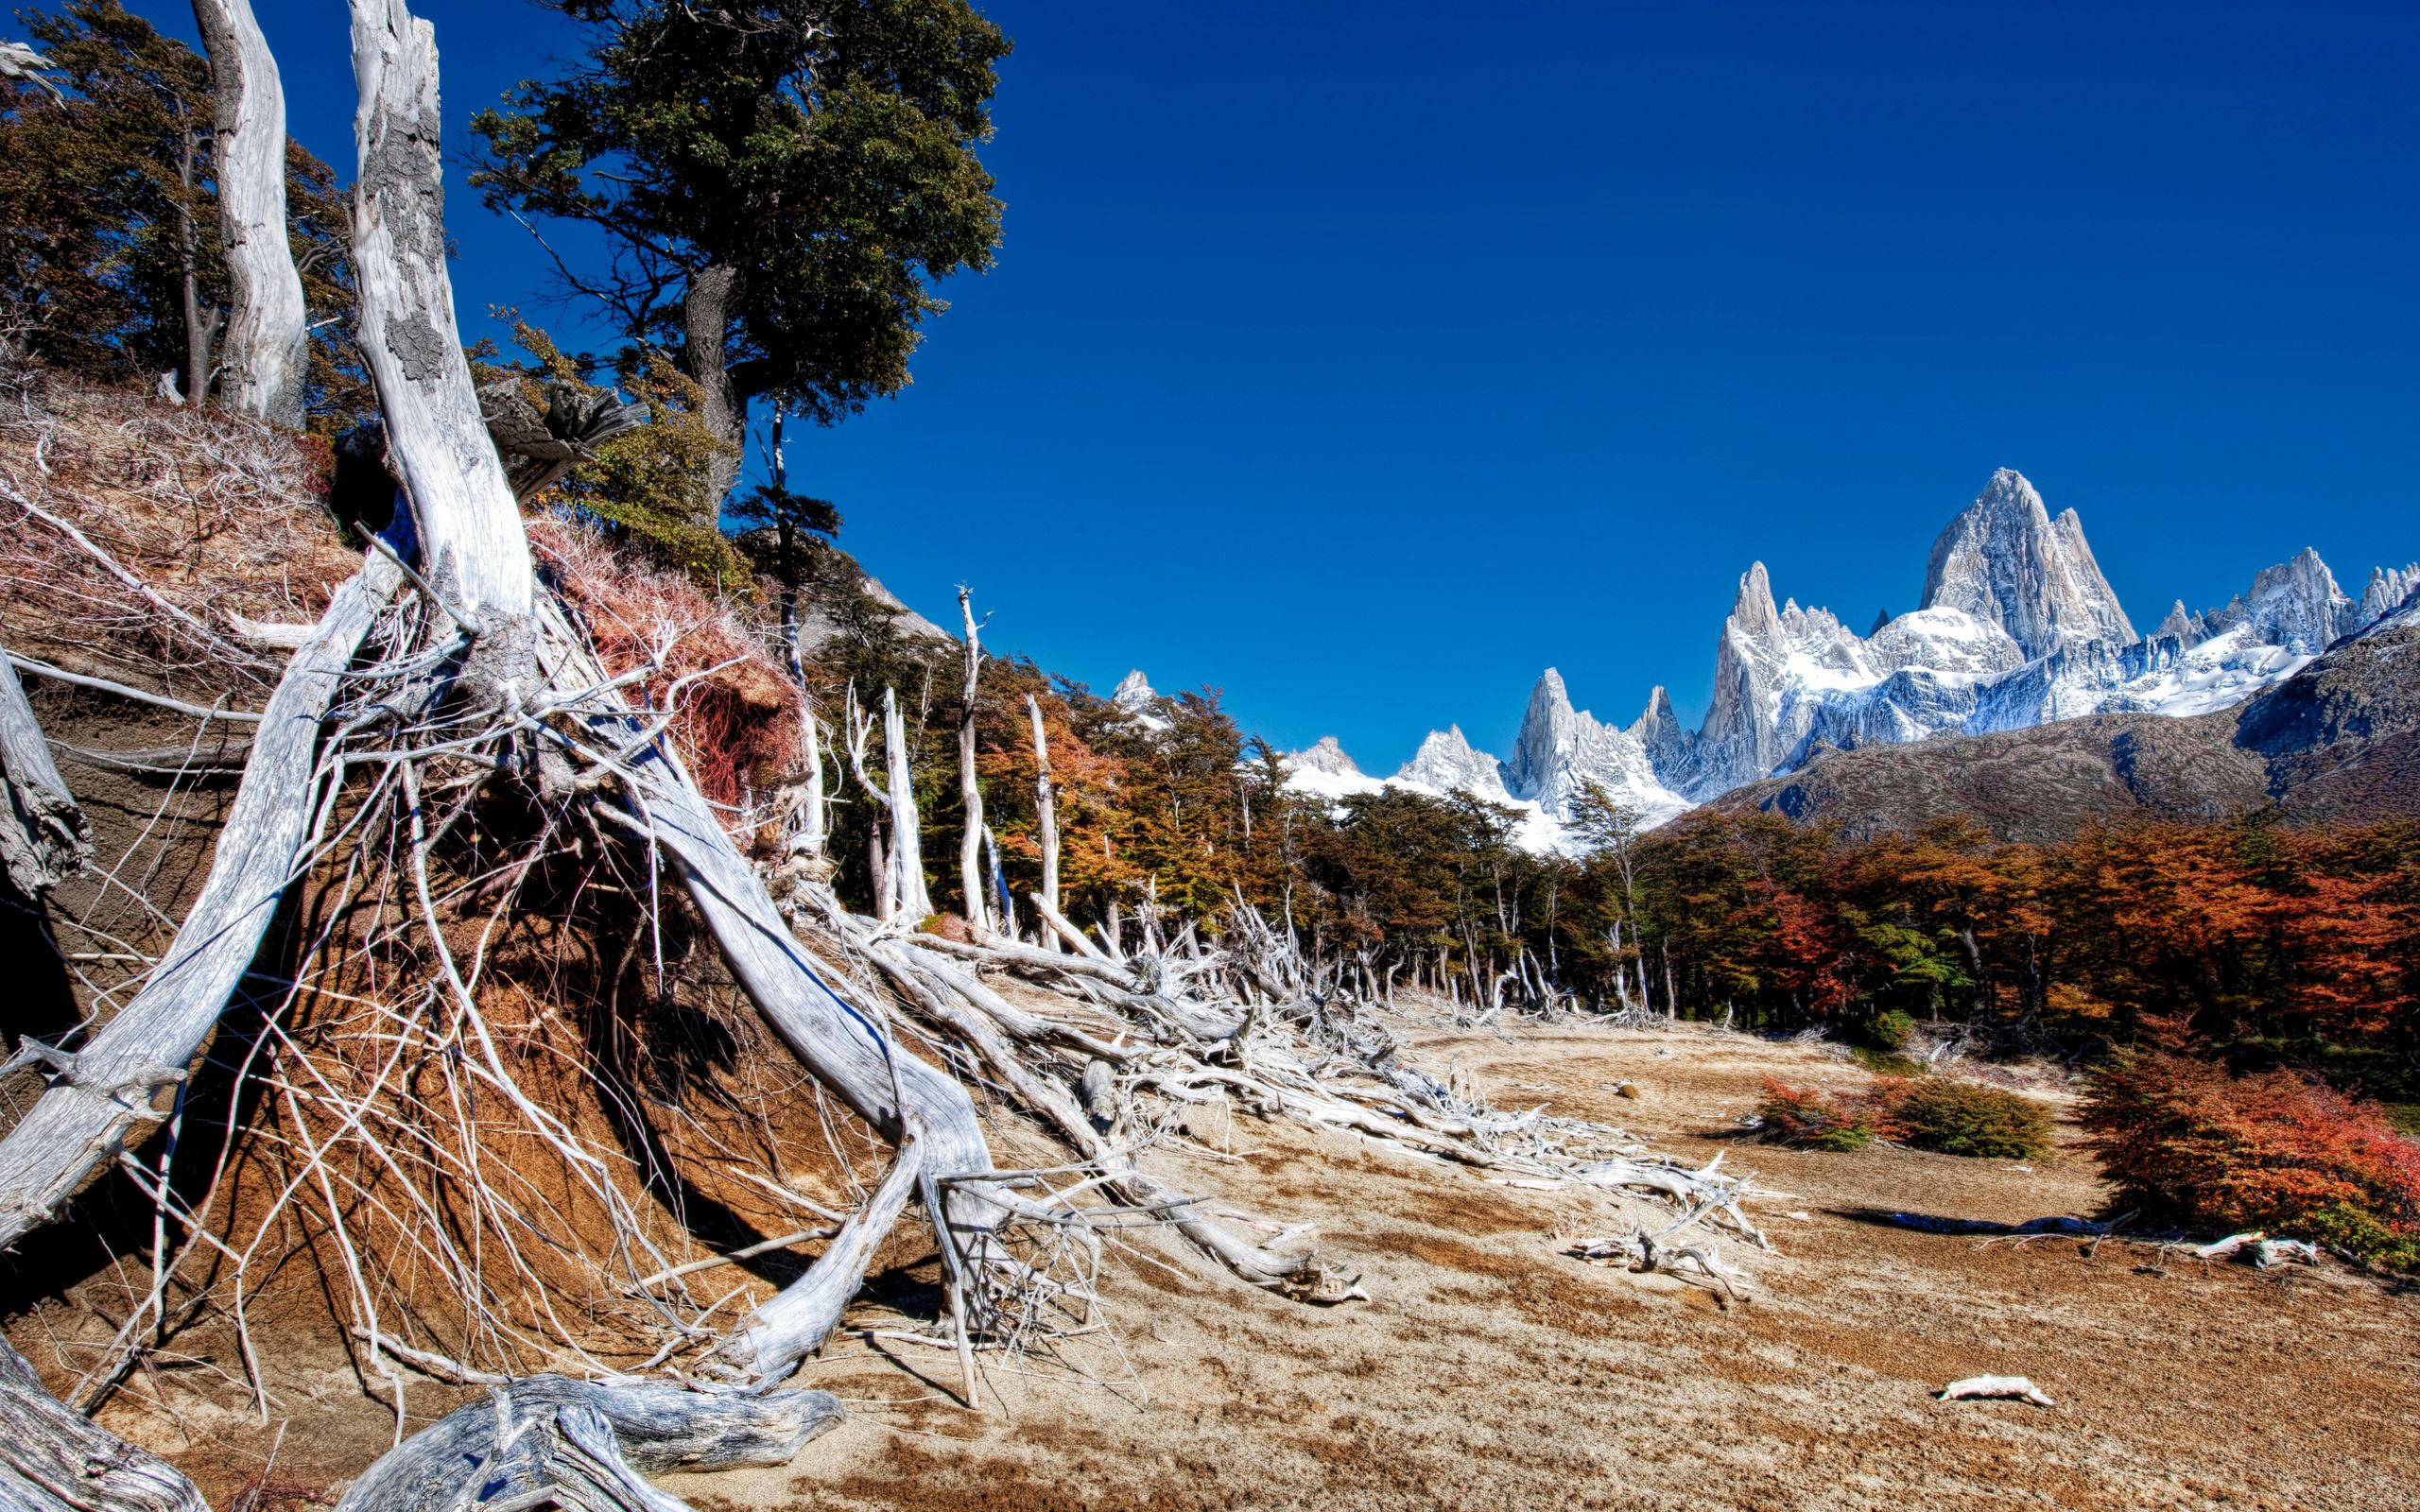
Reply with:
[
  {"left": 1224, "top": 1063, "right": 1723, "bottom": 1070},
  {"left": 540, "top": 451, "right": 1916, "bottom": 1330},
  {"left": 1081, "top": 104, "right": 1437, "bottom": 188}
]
[{"left": 23, "top": 1025, "right": 2420, "bottom": 1512}]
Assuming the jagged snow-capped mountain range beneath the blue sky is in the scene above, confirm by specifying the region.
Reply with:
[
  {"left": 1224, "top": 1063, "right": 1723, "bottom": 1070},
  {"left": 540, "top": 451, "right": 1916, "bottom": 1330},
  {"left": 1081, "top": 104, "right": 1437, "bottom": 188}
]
[{"left": 1297, "top": 467, "right": 2420, "bottom": 841}]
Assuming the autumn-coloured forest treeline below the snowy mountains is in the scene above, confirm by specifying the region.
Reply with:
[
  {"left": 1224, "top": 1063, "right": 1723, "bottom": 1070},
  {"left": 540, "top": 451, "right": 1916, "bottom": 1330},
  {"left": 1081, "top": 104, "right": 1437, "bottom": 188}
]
[{"left": 788, "top": 610, "right": 2420, "bottom": 1093}]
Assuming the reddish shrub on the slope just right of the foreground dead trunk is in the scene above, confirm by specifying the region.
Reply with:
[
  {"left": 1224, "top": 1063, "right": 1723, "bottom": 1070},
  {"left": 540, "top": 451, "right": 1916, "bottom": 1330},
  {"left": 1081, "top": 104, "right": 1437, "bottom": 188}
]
[{"left": 530, "top": 520, "right": 804, "bottom": 828}]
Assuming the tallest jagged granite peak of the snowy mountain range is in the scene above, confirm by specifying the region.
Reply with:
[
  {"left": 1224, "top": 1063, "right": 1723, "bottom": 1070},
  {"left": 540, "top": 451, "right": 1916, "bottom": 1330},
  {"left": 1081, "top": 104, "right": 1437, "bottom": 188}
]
[{"left": 1924, "top": 467, "right": 2136, "bottom": 658}]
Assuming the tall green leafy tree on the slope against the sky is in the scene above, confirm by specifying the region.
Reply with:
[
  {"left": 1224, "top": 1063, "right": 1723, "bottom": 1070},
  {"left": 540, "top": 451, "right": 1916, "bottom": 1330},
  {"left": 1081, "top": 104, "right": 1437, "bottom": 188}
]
[{"left": 472, "top": 0, "right": 1010, "bottom": 512}]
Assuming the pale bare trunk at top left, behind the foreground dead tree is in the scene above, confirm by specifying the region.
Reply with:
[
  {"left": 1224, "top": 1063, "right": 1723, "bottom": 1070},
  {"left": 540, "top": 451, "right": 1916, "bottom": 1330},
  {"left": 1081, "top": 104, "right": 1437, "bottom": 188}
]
[{"left": 194, "top": 0, "right": 310, "bottom": 428}]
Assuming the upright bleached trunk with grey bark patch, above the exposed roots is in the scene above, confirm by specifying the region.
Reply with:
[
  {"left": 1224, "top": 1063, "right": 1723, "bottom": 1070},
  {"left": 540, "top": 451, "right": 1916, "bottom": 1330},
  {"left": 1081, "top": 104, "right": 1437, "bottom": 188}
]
[{"left": 351, "top": 0, "right": 537, "bottom": 624}]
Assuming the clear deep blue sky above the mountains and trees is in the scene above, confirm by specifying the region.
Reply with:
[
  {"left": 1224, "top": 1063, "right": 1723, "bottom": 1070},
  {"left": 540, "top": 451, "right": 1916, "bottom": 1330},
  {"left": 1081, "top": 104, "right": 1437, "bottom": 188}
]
[{"left": 138, "top": 0, "right": 2420, "bottom": 769}]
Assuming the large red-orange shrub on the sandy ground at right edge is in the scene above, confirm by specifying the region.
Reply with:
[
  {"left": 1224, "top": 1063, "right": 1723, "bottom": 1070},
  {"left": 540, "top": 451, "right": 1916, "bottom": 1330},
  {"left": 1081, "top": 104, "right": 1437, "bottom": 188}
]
[{"left": 2083, "top": 1053, "right": 2420, "bottom": 1270}]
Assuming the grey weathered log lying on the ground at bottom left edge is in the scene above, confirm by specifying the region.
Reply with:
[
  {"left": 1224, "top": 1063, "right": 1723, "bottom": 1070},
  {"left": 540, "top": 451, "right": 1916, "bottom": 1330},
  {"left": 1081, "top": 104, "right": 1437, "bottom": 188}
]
[{"left": 337, "top": 1377, "right": 839, "bottom": 1512}]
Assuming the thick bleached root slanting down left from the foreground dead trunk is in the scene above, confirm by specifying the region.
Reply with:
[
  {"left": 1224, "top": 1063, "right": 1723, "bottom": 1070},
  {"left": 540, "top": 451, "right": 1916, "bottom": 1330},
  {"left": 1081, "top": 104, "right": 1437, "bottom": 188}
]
[{"left": 0, "top": 554, "right": 405, "bottom": 1248}]
